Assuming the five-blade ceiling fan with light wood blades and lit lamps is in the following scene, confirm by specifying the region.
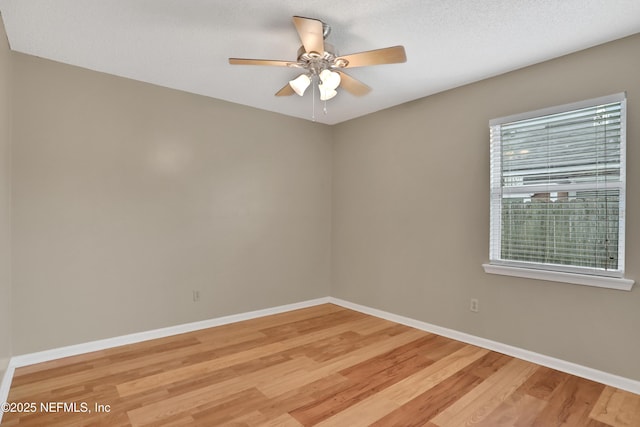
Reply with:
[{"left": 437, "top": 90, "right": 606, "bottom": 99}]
[{"left": 229, "top": 16, "right": 407, "bottom": 101}]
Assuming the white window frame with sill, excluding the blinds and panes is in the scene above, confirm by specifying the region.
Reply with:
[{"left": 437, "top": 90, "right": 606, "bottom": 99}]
[{"left": 483, "top": 92, "right": 634, "bottom": 291}]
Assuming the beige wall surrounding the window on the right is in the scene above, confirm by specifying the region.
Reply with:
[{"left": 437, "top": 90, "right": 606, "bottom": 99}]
[{"left": 332, "top": 35, "right": 640, "bottom": 380}]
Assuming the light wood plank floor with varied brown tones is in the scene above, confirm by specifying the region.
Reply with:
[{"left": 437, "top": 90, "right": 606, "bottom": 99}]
[{"left": 2, "top": 304, "right": 640, "bottom": 427}]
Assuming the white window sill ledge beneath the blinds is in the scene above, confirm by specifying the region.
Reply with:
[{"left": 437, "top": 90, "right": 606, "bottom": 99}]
[{"left": 482, "top": 264, "right": 635, "bottom": 291}]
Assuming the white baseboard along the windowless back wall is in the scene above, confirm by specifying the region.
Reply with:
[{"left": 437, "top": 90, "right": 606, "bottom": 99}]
[{"left": 10, "top": 297, "right": 329, "bottom": 368}]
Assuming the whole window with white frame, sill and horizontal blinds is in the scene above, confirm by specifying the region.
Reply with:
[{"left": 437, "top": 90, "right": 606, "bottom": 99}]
[{"left": 485, "top": 93, "right": 633, "bottom": 289}]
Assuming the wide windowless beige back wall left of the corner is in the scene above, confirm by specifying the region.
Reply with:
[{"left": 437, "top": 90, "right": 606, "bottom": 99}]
[{"left": 13, "top": 53, "right": 331, "bottom": 354}]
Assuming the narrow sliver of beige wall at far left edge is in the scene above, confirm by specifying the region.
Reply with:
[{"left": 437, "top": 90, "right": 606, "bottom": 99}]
[{"left": 0, "top": 15, "right": 11, "bottom": 372}]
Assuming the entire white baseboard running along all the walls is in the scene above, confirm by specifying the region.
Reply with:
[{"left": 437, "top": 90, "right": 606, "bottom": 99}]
[{"left": 0, "top": 297, "right": 640, "bottom": 422}]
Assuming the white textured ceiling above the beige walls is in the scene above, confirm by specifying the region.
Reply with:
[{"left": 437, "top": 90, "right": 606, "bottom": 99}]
[{"left": 0, "top": 0, "right": 640, "bottom": 124}]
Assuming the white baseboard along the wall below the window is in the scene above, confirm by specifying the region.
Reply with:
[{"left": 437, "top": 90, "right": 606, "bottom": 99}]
[{"left": 329, "top": 297, "right": 640, "bottom": 394}]
